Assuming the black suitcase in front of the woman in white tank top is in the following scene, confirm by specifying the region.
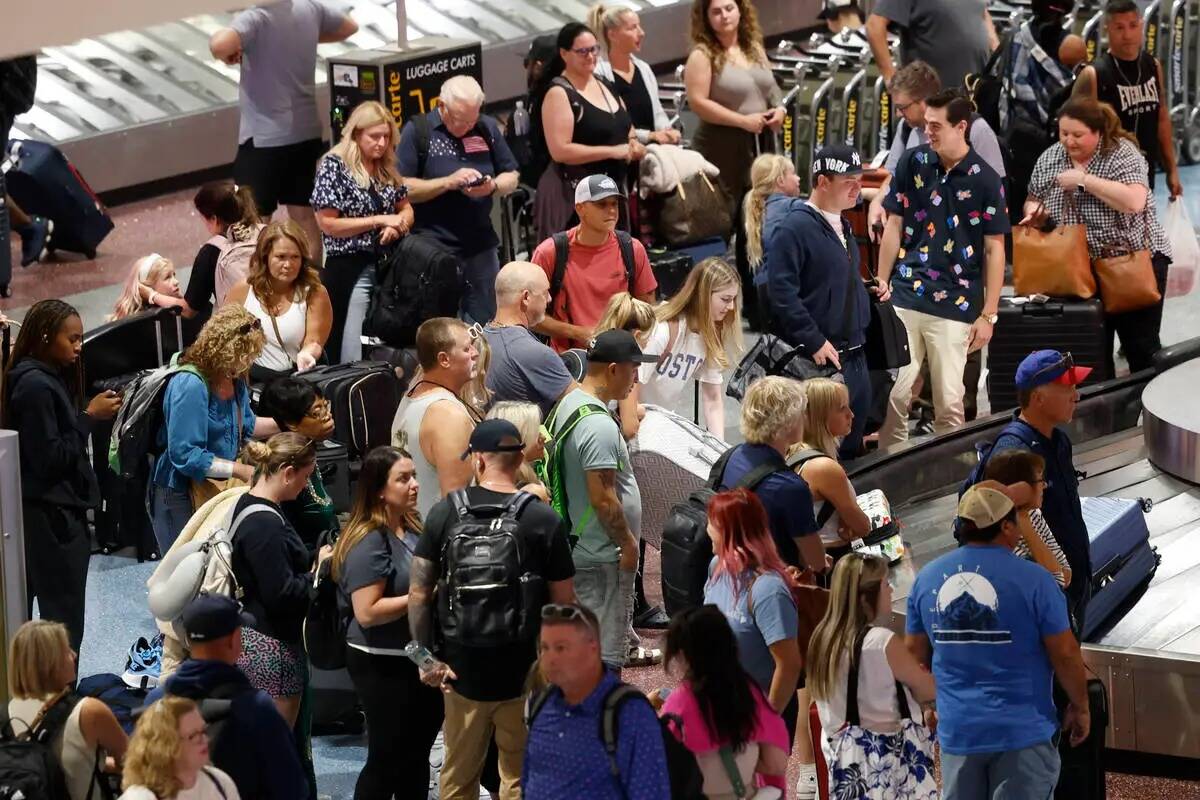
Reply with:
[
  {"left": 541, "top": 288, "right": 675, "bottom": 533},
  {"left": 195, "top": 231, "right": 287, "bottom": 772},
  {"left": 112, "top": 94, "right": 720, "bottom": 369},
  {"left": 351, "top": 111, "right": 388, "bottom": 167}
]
[{"left": 296, "top": 361, "right": 401, "bottom": 461}]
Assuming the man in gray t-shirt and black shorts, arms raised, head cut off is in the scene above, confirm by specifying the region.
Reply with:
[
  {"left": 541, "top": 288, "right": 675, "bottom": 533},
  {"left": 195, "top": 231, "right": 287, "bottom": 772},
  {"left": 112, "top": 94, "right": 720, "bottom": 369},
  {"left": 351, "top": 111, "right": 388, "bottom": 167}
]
[{"left": 209, "top": 0, "right": 359, "bottom": 255}]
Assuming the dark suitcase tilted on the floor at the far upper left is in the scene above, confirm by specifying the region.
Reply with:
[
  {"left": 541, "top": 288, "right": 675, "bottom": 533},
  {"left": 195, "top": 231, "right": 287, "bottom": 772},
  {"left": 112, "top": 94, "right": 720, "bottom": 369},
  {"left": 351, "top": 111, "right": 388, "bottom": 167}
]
[{"left": 6, "top": 139, "right": 113, "bottom": 258}]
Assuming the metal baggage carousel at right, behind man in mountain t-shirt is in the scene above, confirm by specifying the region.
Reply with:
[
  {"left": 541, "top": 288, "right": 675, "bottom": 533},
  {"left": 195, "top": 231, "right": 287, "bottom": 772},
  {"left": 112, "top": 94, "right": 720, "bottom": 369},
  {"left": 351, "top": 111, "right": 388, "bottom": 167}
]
[{"left": 851, "top": 339, "right": 1200, "bottom": 758}]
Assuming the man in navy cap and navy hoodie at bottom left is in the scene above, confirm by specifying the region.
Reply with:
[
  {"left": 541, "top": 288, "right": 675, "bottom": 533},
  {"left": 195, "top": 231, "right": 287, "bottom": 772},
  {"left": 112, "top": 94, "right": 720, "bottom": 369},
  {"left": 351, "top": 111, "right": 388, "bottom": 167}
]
[{"left": 146, "top": 595, "right": 310, "bottom": 800}]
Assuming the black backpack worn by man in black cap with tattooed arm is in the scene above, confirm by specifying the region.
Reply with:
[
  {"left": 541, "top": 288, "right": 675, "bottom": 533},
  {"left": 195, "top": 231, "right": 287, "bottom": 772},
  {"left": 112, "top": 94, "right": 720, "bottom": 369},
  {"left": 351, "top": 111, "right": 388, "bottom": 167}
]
[{"left": 438, "top": 489, "right": 545, "bottom": 648}]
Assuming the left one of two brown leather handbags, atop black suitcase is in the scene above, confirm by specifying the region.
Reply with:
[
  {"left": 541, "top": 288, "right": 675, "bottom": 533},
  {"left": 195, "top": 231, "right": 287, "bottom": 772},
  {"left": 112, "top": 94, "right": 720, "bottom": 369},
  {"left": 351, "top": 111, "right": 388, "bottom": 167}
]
[{"left": 1013, "top": 200, "right": 1096, "bottom": 300}]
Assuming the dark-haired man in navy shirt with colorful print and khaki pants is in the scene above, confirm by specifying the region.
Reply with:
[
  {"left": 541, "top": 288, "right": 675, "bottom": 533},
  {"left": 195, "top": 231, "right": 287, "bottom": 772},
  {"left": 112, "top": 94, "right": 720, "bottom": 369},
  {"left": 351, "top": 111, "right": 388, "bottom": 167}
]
[{"left": 880, "top": 90, "right": 1009, "bottom": 449}]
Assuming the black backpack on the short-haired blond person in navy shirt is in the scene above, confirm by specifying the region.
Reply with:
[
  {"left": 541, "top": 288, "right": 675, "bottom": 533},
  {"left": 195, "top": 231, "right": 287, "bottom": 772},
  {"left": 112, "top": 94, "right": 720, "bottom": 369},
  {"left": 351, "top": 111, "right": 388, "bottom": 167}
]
[{"left": 660, "top": 447, "right": 787, "bottom": 616}]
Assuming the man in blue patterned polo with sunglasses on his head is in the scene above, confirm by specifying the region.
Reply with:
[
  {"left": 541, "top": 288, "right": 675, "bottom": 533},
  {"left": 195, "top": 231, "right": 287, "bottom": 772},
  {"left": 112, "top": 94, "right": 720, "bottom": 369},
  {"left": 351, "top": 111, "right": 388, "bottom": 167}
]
[{"left": 521, "top": 604, "right": 671, "bottom": 800}]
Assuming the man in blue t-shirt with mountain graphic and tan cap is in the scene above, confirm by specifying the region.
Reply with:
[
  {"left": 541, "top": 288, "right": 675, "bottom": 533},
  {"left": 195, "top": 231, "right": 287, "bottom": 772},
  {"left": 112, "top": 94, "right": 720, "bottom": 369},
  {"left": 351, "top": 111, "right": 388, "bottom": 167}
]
[{"left": 906, "top": 481, "right": 1091, "bottom": 800}]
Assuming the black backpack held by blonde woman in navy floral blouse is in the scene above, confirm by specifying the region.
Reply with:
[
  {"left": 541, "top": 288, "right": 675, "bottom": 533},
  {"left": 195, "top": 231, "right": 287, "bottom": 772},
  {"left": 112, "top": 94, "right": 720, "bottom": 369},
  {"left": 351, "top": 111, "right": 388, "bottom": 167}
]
[{"left": 362, "top": 234, "right": 462, "bottom": 347}]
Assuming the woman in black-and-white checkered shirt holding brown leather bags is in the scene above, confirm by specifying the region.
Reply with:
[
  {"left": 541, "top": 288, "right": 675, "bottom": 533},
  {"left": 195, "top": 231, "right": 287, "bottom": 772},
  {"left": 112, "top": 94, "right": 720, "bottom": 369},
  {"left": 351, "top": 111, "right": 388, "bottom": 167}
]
[{"left": 1021, "top": 97, "right": 1171, "bottom": 372}]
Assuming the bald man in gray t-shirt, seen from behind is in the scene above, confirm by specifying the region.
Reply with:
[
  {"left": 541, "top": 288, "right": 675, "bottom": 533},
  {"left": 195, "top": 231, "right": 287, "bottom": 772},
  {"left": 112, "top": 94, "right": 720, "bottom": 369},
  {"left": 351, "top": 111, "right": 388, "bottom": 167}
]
[{"left": 484, "top": 261, "right": 575, "bottom": 420}]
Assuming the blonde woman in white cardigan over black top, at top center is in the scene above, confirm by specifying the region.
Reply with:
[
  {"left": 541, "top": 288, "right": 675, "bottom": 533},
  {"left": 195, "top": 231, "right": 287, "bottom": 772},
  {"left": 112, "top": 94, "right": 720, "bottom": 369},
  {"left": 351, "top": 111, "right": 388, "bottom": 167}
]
[{"left": 588, "top": 2, "right": 679, "bottom": 144}]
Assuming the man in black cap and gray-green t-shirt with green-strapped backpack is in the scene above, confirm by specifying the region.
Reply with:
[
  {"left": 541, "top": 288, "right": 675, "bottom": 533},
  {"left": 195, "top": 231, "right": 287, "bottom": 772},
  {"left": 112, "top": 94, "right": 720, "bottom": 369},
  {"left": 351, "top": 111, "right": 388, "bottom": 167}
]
[{"left": 547, "top": 330, "right": 658, "bottom": 669}]
